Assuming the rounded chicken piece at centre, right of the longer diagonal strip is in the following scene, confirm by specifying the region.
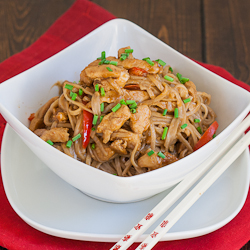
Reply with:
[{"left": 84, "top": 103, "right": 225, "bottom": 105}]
[{"left": 130, "top": 105, "right": 151, "bottom": 135}]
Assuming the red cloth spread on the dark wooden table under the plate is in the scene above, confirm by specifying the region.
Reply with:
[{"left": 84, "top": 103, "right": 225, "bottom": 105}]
[{"left": 0, "top": 0, "right": 250, "bottom": 250}]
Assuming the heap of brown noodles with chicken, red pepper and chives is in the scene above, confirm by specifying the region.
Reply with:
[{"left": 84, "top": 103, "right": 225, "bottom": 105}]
[{"left": 30, "top": 47, "right": 216, "bottom": 176}]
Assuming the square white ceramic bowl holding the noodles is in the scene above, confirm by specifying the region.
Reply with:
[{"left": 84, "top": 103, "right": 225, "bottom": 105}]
[{"left": 0, "top": 19, "right": 250, "bottom": 202}]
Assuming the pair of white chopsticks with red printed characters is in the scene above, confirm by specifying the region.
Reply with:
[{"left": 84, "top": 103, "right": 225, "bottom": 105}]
[{"left": 111, "top": 115, "right": 250, "bottom": 250}]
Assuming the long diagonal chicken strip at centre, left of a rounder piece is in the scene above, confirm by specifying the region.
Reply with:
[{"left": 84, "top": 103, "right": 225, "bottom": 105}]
[{"left": 96, "top": 105, "right": 131, "bottom": 143}]
